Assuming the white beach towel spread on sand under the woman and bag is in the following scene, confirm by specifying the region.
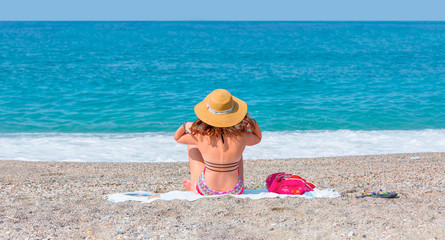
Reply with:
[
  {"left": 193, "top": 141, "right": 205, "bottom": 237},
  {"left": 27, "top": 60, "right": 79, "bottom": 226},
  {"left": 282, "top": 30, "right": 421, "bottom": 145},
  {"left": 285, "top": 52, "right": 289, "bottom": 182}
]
[{"left": 104, "top": 188, "right": 340, "bottom": 203}]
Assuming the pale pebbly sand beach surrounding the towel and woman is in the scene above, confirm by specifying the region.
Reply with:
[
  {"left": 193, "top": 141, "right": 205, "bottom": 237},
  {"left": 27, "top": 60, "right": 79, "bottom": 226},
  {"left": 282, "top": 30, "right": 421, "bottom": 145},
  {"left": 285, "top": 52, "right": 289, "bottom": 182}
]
[{"left": 0, "top": 153, "right": 445, "bottom": 239}]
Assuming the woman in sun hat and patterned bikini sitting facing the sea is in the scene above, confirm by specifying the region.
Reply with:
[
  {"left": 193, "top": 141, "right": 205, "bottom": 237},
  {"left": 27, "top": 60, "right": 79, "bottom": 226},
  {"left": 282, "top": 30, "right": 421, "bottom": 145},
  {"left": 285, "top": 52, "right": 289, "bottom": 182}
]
[{"left": 174, "top": 89, "right": 261, "bottom": 195}]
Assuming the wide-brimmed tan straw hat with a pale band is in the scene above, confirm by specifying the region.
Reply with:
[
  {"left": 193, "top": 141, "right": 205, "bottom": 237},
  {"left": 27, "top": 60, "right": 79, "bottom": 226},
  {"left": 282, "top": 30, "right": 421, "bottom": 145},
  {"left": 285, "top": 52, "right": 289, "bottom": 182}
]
[{"left": 195, "top": 89, "right": 247, "bottom": 127}]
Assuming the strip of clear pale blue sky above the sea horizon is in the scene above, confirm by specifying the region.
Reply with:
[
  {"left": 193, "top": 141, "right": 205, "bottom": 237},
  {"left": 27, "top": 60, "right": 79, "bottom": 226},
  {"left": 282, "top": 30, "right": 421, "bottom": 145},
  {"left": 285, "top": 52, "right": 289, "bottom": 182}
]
[{"left": 0, "top": 0, "right": 445, "bottom": 21}]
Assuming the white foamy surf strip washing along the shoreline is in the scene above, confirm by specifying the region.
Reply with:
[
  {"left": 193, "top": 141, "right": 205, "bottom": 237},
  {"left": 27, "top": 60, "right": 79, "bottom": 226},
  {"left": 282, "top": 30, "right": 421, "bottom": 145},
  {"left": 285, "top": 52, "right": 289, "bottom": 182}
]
[{"left": 0, "top": 129, "right": 445, "bottom": 162}]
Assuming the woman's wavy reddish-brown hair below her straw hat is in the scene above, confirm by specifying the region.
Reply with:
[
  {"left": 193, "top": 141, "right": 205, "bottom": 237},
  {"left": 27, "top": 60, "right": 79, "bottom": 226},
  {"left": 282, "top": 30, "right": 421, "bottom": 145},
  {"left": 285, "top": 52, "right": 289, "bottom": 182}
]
[{"left": 190, "top": 114, "right": 256, "bottom": 137}]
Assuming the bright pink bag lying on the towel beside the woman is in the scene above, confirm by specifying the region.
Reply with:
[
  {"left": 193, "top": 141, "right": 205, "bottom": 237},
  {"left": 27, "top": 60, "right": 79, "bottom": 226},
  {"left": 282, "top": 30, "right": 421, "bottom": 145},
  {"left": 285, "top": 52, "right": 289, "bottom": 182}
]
[{"left": 266, "top": 172, "right": 315, "bottom": 195}]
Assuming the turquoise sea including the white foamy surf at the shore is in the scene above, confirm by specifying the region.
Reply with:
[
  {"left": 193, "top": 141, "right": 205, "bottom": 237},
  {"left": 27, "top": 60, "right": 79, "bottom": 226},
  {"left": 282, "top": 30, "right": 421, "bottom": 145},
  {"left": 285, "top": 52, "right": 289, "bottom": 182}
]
[{"left": 0, "top": 22, "right": 445, "bottom": 162}]
